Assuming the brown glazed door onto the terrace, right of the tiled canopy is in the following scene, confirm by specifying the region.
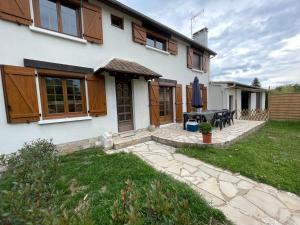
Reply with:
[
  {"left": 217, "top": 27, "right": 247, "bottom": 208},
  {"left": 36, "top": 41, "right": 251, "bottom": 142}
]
[{"left": 159, "top": 87, "right": 173, "bottom": 124}]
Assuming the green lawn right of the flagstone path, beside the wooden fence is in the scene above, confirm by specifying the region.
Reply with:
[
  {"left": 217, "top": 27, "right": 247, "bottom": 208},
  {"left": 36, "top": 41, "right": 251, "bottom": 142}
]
[{"left": 177, "top": 121, "right": 300, "bottom": 195}]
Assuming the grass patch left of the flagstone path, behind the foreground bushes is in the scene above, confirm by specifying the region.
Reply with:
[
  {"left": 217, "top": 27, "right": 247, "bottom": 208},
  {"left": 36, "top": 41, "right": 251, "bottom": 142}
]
[{"left": 0, "top": 149, "right": 229, "bottom": 225}]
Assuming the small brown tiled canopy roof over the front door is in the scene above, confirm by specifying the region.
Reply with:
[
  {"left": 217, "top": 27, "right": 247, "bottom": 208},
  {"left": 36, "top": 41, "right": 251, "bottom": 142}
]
[{"left": 96, "top": 58, "right": 162, "bottom": 78}]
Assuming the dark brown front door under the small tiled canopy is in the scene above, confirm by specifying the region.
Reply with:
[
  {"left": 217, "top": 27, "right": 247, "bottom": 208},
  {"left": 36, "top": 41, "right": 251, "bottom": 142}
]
[{"left": 116, "top": 78, "right": 133, "bottom": 132}]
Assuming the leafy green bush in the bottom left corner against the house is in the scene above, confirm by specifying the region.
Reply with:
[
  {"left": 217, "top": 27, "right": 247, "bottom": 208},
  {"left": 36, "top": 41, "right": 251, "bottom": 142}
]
[{"left": 0, "top": 139, "right": 91, "bottom": 225}]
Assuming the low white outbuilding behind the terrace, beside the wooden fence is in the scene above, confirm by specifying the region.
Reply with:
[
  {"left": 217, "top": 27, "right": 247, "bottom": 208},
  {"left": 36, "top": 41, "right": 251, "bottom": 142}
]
[{"left": 208, "top": 81, "right": 266, "bottom": 116}]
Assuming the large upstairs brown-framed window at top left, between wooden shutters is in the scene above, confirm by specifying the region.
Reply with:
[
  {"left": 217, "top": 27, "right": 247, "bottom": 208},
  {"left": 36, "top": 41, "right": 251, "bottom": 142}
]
[{"left": 34, "top": 0, "right": 81, "bottom": 36}]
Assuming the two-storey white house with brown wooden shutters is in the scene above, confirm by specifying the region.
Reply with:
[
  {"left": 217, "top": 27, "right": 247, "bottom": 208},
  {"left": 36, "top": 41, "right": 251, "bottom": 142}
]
[{"left": 0, "top": 0, "right": 216, "bottom": 153}]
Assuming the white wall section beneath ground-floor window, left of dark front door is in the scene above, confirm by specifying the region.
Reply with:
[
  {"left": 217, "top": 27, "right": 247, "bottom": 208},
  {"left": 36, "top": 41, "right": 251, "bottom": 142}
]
[{"left": 0, "top": 71, "right": 117, "bottom": 153}]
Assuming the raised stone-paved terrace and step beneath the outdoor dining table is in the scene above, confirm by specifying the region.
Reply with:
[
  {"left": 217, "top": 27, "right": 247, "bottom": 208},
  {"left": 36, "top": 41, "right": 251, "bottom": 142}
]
[{"left": 113, "top": 120, "right": 265, "bottom": 149}]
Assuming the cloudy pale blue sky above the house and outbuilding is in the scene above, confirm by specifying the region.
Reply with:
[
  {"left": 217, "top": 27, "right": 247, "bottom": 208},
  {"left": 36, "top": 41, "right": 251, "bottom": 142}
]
[{"left": 119, "top": 0, "right": 300, "bottom": 88}]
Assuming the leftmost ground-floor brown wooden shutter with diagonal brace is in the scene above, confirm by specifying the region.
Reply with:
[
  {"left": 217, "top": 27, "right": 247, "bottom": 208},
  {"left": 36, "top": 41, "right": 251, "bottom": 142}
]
[{"left": 2, "top": 66, "right": 40, "bottom": 123}]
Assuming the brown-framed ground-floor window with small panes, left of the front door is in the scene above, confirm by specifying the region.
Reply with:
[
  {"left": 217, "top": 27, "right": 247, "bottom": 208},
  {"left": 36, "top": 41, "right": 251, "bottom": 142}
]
[{"left": 40, "top": 74, "right": 86, "bottom": 118}]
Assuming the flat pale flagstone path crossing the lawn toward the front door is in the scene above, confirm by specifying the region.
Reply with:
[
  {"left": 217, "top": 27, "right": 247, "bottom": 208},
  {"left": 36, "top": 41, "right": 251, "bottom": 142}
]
[{"left": 107, "top": 141, "right": 300, "bottom": 225}]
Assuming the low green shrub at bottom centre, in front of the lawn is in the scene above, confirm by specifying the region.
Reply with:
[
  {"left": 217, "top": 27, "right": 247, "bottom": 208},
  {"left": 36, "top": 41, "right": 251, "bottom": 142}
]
[{"left": 111, "top": 181, "right": 197, "bottom": 225}]
